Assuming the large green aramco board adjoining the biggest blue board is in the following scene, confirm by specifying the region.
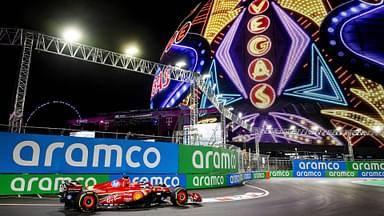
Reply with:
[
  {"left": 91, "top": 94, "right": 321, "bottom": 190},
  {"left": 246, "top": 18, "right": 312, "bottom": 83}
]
[{"left": 179, "top": 145, "right": 239, "bottom": 174}]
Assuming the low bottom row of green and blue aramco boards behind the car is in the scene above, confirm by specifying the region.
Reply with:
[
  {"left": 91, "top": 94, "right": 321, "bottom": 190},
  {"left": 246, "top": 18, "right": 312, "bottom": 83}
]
[{"left": 0, "top": 172, "right": 267, "bottom": 195}]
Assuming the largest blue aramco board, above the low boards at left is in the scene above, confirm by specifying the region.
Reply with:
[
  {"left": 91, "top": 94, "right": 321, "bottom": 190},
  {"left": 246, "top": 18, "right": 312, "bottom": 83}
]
[{"left": 0, "top": 133, "right": 178, "bottom": 173}]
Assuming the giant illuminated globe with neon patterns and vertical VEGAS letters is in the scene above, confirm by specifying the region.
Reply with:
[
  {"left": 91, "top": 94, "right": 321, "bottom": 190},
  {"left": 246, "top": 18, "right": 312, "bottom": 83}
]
[{"left": 150, "top": 0, "right": 384, "bottom": 152}]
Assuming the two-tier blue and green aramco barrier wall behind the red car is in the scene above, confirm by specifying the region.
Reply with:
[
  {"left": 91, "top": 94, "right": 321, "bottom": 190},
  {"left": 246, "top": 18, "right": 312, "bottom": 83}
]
[{"left": 0, "top": 132, "right": 248, "bottom": 195}]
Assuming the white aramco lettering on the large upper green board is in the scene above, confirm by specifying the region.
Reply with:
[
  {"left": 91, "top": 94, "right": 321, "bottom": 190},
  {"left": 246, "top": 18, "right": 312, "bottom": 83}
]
[{"left": 192, "top": 150, "right": 237, "bottom": 170}]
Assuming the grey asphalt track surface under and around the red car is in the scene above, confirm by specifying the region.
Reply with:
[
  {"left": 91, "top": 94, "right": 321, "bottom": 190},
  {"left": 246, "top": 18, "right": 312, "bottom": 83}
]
[{"left": 0, "top": 179, "right": 384, "bottom": 216}]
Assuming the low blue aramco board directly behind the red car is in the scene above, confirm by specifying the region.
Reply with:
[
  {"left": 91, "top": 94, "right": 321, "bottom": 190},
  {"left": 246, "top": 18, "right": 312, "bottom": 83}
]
[{"left": 110, "top": 173, "right": 187, "bottom": 188}]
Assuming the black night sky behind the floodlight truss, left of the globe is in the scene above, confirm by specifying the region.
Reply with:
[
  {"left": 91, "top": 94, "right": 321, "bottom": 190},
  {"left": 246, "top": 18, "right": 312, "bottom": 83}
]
[{"left": 0, "top": 0, "right": 201, "bottom": 127}]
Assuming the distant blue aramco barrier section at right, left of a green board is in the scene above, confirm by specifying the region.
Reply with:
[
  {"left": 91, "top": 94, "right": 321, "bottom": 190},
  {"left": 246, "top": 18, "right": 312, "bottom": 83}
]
[{"left": 292, "top": 160, "right": 347, "bottom": 177}]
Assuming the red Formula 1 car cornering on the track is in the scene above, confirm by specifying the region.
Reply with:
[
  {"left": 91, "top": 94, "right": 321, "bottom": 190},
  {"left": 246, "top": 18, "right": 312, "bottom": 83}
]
[{"left": 60, "top": 177, "right": 202, "bottom": 212}]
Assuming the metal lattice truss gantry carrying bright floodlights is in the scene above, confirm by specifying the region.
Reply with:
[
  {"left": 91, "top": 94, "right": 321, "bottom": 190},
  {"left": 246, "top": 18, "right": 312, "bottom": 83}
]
[{"left": 0, "top": 28, "right": 254, "bottom": 137}]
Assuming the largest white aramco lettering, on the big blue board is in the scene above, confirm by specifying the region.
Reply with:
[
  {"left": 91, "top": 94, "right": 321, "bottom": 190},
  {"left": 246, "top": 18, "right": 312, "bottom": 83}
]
[{"left": 13, "top": 141, "right": 161, "bottom": 169}]
